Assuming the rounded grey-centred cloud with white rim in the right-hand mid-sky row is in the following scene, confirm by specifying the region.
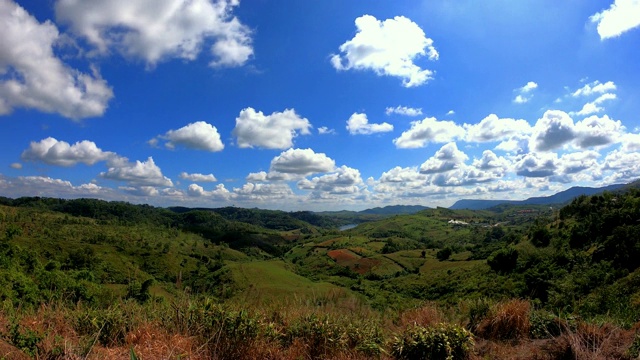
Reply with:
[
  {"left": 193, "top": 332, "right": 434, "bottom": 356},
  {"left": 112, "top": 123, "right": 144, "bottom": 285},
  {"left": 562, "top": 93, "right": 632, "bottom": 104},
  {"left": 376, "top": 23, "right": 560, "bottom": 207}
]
[{"left": 529, "top": 110, "right": 576, "bottom": 151}]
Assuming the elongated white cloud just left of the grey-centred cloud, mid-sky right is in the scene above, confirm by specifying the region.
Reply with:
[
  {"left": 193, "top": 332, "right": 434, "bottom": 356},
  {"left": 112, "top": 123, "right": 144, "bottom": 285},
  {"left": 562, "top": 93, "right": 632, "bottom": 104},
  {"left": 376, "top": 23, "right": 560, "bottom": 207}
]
[{"left": 463, "top": 114, "right": 533, "bottom": 142}]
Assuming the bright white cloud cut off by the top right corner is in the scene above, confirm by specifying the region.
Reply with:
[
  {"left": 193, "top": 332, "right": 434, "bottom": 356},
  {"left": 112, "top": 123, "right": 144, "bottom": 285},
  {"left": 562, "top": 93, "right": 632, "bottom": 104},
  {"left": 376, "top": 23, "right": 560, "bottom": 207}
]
[{"left": 589, "top": 0, "right": 640, "bottom": 40}]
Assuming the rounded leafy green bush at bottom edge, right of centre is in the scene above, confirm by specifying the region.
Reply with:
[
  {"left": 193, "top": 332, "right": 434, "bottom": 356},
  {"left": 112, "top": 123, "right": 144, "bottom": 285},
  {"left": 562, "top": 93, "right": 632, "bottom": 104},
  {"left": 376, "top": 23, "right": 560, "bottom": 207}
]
[{"left": 391, "top": 323, "right": 474, "bottom": 360}]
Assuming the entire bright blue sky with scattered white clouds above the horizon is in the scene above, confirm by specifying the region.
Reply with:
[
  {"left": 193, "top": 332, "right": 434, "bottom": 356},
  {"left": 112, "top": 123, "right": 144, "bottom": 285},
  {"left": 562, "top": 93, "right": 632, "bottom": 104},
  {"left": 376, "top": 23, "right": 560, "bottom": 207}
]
[{"left": 0, "top": 0, "right": 640, "bottom": 211}]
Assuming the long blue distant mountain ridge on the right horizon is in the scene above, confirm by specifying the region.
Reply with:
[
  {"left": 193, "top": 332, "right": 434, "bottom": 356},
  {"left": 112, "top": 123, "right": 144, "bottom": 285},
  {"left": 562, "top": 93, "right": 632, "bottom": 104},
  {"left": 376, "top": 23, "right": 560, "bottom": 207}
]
[{"left": 449, "top": 184, "right": 628, "bottom": 210}]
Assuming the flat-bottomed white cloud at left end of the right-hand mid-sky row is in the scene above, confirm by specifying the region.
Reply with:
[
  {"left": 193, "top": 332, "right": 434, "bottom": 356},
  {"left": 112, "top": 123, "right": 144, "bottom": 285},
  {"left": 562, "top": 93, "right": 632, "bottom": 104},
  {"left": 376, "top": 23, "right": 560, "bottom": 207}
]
[{"left": 393, "top": 117, "right": 465, "bottom": 148}]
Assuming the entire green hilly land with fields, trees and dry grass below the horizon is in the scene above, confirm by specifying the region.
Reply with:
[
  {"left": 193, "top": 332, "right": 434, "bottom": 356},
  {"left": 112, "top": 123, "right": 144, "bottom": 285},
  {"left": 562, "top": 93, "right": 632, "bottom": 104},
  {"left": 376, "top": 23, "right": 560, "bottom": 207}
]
[{"left": 0, "top": 188, "right": 640, "bottom": 359}]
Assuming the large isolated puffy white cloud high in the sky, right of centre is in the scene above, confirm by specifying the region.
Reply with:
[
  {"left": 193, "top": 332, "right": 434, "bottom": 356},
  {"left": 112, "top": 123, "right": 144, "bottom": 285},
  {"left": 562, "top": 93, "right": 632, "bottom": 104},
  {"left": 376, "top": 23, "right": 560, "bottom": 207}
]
[{"left": 331, "top": 15, "right": 439, "bottom": 87}]
